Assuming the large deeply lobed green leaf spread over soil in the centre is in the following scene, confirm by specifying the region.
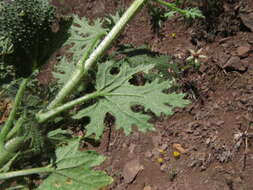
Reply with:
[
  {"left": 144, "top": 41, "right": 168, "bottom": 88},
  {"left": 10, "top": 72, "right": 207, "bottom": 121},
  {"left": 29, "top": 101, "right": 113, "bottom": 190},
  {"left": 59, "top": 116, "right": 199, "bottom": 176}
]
[{"left": 73, "top": 62, "right": 189, "bottom": 139}]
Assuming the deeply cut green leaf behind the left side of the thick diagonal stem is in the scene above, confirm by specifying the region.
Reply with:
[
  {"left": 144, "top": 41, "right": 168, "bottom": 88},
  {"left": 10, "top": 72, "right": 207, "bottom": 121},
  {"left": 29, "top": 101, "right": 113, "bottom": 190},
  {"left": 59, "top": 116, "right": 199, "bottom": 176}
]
[{"left": 53, "top": 15, "right": 107, "bottom": 88}]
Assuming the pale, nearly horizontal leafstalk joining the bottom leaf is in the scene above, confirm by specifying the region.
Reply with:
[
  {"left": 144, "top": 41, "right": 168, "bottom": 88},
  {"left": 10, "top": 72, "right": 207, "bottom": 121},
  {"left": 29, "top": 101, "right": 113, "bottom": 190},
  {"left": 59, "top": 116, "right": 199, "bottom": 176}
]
[{"left": 0, "top": 165, "right": 55, "bottom": 180}]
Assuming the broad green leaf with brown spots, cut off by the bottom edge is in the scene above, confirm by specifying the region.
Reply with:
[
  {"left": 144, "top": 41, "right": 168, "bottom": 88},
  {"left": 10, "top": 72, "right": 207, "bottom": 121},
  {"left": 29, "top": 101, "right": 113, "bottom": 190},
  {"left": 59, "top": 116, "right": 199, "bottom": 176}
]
[{"left": 38, "top": 139, "right": 112, "bottom": 190}]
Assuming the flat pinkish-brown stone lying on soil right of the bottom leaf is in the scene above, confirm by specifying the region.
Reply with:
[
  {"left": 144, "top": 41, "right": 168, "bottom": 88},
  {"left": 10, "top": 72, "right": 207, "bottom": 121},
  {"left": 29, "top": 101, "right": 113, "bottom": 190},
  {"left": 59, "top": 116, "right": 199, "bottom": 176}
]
[{"left": 122, "top": 159, "right": 144, "bottom": 183}]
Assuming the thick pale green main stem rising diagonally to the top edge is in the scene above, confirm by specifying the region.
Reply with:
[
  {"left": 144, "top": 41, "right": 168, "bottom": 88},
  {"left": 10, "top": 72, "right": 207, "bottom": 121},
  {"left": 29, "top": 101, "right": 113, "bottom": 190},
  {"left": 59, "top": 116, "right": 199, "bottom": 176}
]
[{"left": 48, "top": 0, "right": 147, "bottom": 110}]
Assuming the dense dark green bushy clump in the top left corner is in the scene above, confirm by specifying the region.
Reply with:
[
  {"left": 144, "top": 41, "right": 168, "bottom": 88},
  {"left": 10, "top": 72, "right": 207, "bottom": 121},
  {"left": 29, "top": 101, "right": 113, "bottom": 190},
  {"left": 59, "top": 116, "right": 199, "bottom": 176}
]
[{"left": 0, "top": 0, "right": 54, "bottom": 50}]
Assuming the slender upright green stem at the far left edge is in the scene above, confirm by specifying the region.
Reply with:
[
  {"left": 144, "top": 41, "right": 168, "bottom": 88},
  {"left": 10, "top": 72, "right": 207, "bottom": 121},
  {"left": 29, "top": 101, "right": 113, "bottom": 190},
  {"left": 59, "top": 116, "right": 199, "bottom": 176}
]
[{"left": 0, "top": 77, "right": 30, "bottom": 144}]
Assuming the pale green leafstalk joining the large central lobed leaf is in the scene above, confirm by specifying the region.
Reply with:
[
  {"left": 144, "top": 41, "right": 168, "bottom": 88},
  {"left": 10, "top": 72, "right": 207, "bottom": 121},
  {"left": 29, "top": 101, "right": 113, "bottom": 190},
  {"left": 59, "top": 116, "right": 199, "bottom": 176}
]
[{"left": 36, "top": 92, "right": 104, "bottom": 123}]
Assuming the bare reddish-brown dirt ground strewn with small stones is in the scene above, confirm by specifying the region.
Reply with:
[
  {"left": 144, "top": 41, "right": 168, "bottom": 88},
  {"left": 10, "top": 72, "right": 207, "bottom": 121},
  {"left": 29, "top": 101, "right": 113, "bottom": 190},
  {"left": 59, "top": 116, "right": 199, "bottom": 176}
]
[{"left": 44, "top": 0, "right": 253, "bottom": 190}]
